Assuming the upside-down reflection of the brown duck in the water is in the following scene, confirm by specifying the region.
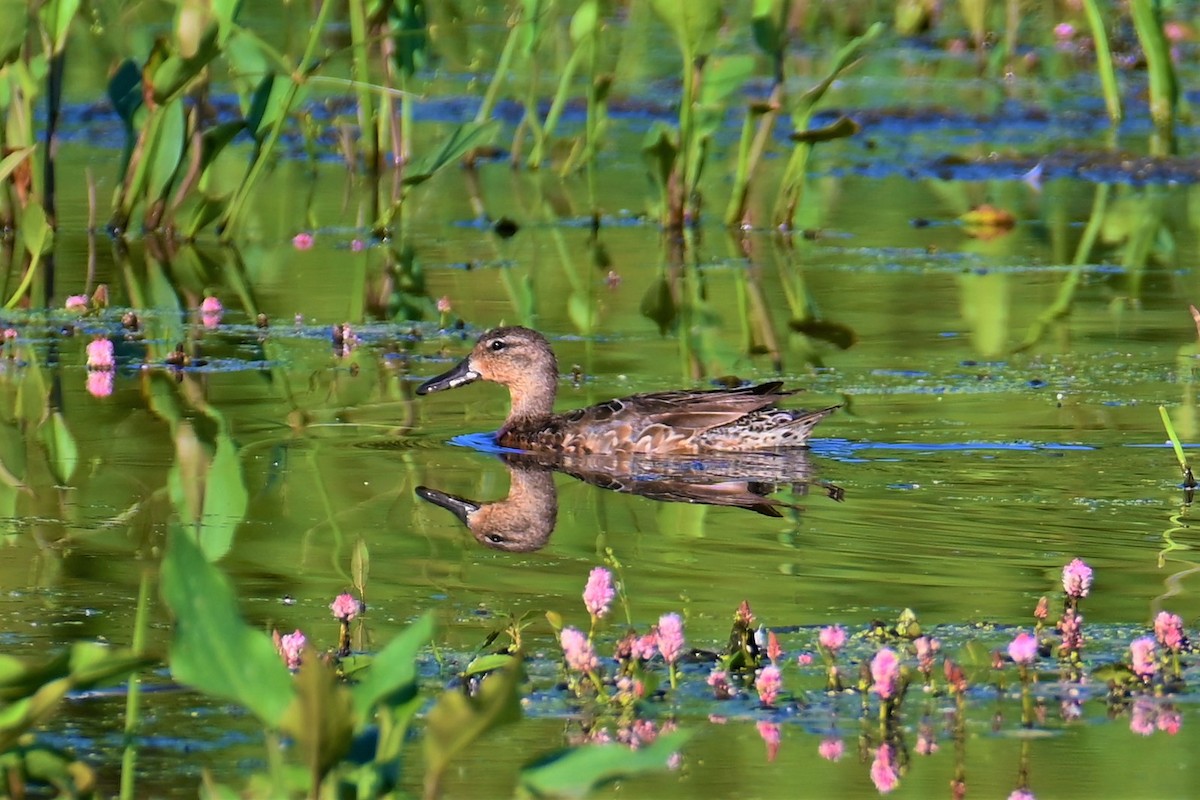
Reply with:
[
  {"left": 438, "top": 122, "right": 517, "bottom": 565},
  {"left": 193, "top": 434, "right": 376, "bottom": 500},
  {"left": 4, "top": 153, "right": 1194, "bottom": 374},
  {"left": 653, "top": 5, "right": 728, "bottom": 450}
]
[{"left": 416, "top": 451, "right": 845, "bottom": 553}]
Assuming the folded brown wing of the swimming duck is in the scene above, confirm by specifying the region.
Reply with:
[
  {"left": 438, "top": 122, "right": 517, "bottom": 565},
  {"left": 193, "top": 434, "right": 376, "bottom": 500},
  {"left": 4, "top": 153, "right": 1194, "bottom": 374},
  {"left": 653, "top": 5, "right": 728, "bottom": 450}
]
[{"left": 563, "top": 381, "right": 794, "bottom": 453}]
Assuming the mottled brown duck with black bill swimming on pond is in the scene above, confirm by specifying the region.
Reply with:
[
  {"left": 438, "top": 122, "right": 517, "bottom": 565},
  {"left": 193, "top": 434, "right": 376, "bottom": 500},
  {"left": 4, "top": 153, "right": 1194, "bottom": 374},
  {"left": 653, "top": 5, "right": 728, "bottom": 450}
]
[{"left": 416, "top": 326, "right": 841, "bottom": 455}]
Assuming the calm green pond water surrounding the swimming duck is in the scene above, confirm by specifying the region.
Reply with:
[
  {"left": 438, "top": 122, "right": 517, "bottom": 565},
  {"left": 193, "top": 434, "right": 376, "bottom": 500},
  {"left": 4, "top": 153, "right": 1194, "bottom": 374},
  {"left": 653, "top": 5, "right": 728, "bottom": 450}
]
[{"left": 0, "top": 1, "right": 1200, "bottom": 798}]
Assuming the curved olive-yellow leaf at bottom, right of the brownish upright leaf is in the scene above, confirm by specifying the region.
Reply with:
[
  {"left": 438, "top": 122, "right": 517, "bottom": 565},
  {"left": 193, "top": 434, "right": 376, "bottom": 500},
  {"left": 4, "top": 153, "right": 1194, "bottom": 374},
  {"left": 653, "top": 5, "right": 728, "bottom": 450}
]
[{"left": 425, "top": 658, "right": 523, "bottom": 796}]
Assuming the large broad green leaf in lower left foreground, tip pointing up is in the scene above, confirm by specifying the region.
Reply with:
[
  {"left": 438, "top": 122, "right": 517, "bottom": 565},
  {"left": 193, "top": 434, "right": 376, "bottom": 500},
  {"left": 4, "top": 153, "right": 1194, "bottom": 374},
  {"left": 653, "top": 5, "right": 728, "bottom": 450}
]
[{"left": 162, "top": 525, "right": 295, "bottom": 728}]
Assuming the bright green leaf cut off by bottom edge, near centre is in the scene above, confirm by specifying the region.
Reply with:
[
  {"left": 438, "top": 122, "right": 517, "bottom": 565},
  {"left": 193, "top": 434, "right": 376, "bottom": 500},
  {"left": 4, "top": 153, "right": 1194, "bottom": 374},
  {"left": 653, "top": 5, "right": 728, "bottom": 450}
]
[{"left": 520, "top": 730, "right": 691, "bottom": 798}]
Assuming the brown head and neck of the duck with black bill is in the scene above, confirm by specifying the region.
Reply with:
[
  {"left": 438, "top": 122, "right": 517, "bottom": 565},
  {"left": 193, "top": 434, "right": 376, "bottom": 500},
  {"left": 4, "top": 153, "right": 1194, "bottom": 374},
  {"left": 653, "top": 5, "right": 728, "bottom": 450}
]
[{"left": 416, "top": 327, "right": 558, "bottom": 411}]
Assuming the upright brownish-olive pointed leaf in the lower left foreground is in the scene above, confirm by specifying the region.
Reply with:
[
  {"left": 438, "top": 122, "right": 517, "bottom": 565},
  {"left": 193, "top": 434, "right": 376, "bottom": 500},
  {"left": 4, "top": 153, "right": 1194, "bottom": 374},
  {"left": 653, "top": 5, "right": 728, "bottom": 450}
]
[{"left": 280, "top": 648, "right": 354, "bottom": 784}]
